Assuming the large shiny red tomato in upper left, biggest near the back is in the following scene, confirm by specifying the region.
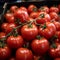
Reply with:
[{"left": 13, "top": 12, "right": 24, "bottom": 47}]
[{"left": 14, "top": 9, "right": 29, "bottom": 23}]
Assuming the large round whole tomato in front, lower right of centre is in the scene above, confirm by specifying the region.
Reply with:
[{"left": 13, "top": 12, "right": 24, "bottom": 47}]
[{"left": 31, "top": 38, "right": 49, "bottom": 56}]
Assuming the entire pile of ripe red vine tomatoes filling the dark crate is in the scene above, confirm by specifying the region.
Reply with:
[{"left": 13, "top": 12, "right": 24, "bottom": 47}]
[{"left": 0, "top": 4, "right": 60, "bottom": 60}]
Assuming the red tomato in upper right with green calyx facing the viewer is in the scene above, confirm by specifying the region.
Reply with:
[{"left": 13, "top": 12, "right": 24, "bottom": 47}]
[{"left": 36, "top": 12, "right": 51, "bottom": 24}]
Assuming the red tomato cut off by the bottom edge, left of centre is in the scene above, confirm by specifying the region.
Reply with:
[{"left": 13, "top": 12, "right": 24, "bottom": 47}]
[{"left": 16, "top": 48, "right": 33, "bottom": 60}]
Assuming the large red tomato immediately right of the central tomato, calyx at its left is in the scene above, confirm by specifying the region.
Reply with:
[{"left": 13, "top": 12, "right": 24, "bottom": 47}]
[{"left": 39, "top": 22, "right": 56, "bottom": 39}]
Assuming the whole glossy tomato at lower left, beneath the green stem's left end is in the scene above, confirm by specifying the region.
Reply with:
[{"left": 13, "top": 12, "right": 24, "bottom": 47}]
[{"left": 7, "top": 36, "right": 24, "bottom": 48}]
